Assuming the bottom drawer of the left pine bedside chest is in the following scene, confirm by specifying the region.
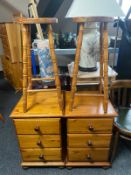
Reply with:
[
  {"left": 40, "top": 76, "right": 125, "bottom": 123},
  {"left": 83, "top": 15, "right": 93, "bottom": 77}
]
[{"left": 21, "top": 148, "right": 62, "bottom": 162}]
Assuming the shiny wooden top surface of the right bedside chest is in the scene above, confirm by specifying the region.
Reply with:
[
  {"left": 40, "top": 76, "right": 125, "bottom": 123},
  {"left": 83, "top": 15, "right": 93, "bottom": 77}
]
[{"left": 65, "top": 92, "right": 117, "bottom": 118}]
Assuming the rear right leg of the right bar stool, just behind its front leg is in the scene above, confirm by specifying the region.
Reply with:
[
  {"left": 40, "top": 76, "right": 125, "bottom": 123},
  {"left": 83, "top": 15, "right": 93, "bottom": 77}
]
[{"left": 100, "top": 22, "right": 103, "bottom": 94}]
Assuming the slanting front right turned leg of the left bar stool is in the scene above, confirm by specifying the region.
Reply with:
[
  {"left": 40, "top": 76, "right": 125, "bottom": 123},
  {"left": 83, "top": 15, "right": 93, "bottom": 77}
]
[{"left": 48, "top": 24, "right": 63, "bottom": 110}]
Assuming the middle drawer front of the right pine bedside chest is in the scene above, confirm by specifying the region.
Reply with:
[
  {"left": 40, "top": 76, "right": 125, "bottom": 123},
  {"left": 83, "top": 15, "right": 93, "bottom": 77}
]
[{"left": 67, "top": 134, "right": 112, "bottom": 148}]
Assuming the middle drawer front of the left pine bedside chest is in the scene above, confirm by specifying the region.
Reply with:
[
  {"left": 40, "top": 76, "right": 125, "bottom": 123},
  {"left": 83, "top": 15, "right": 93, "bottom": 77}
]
[{"left": 18, "top": 135, "right": 61, "bottom": 148}]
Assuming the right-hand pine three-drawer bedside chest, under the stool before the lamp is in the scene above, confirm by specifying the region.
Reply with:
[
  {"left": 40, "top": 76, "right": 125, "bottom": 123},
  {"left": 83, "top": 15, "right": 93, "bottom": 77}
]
[{"left": 65, "top": 92, "right": 117, "bottom": 167}]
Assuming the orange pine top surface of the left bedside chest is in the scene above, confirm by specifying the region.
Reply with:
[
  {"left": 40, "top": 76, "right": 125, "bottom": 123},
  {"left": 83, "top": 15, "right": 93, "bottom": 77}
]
[{"left": 11, "top": 92, "right": 62, "bottom": 118}]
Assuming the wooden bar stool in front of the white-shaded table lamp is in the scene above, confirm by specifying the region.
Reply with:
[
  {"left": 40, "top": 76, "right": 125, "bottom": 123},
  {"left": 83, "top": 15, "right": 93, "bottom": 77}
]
[{"left": 70, "top": 17, "right": 113, "bottom": 113}]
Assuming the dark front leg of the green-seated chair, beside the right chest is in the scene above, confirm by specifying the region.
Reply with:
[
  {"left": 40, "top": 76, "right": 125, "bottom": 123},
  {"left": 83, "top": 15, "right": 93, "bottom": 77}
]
[{"left": 111, "top": 131, "right": 120, "bottom": 162}]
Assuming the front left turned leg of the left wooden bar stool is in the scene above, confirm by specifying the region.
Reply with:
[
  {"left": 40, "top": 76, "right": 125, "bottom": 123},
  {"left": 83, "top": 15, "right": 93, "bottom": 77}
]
[{"left": 22, "top": 25, "right": 28, "bottom": 112}]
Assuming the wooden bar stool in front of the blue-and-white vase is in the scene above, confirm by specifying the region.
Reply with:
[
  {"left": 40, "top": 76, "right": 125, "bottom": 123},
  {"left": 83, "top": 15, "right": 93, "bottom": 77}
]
[{"left": 16, "top": 17, "right": 63, "bottom": 112}]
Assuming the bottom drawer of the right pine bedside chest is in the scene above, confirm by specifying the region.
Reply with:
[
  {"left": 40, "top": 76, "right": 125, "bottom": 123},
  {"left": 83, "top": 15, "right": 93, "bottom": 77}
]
[{"left": 68, "top": 148, "right": 109, "bottom": 162}]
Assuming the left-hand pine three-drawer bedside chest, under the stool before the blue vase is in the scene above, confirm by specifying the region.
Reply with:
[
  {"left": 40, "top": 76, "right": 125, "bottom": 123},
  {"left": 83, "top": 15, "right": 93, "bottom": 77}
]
[{"left": 11, "top": 92, "right": 64, "bottom": 166}]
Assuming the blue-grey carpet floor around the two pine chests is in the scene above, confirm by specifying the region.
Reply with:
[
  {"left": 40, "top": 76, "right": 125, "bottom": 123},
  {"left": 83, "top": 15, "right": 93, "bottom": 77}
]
[{"left": 0, "top": 75, "right": 131, "bottom": 175}]
